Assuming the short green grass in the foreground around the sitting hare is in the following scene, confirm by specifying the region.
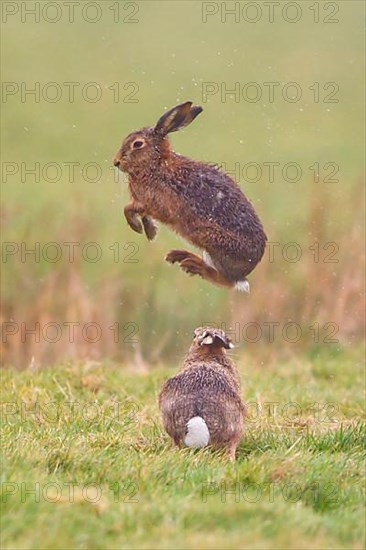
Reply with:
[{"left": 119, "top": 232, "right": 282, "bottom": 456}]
[{"left": 2, "top": 352, "right": 366, "bottom": 549}]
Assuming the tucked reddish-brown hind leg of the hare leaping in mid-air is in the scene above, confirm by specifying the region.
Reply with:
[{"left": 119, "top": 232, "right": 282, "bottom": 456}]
[{"left": 165, "top": 250, "right": 234, "bottom": 288}]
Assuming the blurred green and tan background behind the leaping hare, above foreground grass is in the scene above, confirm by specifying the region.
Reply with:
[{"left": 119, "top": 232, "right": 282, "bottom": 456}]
[{"left": 2, "top": 1, "right": 364, "bottom": 368}]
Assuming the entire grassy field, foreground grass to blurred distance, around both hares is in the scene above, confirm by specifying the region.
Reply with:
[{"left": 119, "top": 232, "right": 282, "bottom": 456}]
[{"left": 1, "top": 0, "right": 365, "bottom": 550}]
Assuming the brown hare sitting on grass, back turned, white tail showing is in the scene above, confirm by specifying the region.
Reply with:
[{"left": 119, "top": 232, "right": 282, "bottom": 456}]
[{"left": 159, "top": 328, "right": 245, "bottom": 461}]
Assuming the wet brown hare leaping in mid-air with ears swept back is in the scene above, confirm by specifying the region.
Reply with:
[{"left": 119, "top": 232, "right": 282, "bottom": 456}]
[{"left": 113, "top": 101, "right": 267, "bottom": 292}]
